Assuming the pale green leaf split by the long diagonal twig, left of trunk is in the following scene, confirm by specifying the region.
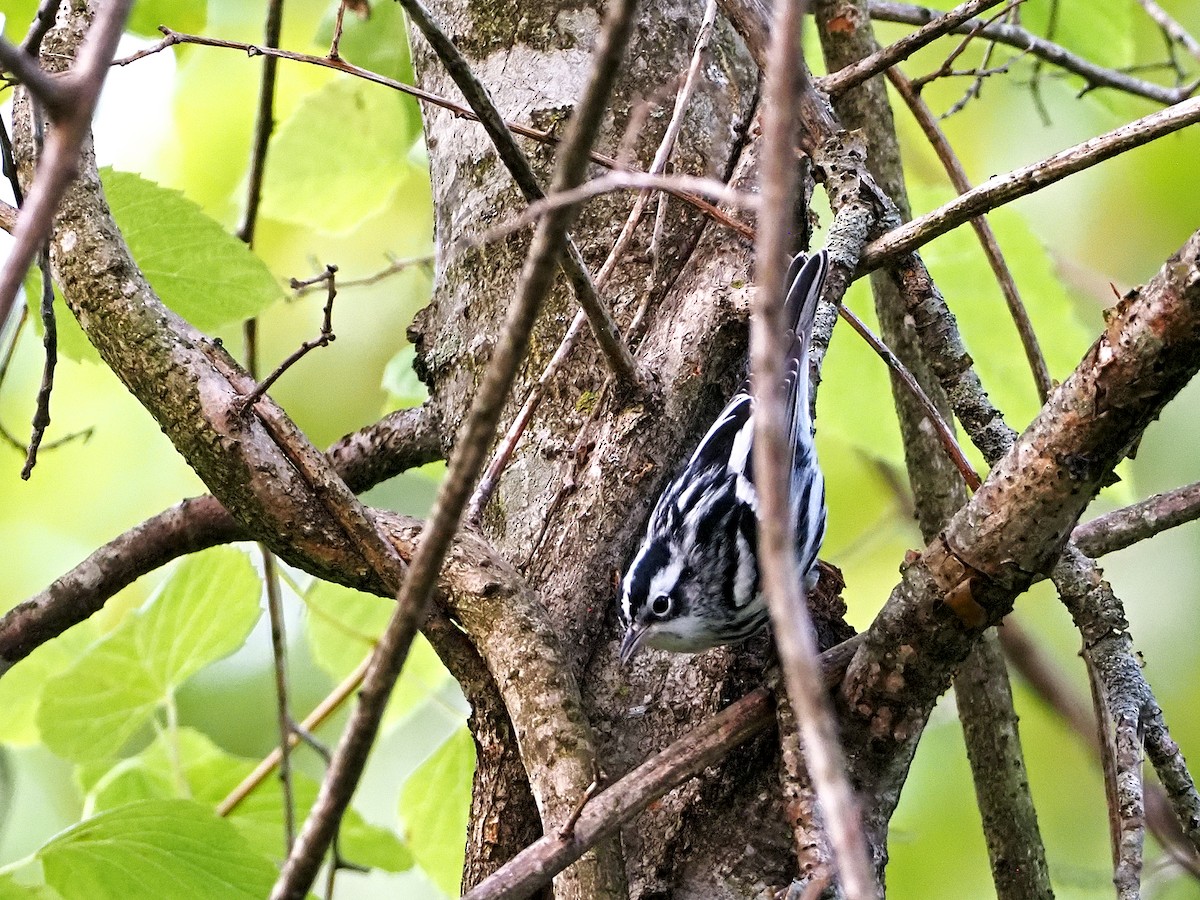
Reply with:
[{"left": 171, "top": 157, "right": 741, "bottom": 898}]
[{"left": 305, "top": 581, "right": 457, "bottom": 724}]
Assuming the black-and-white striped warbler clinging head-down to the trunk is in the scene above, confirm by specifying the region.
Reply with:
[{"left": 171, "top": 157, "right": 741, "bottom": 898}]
[{"left": 620, "top": 251, "right": 828, "bottom": 662}]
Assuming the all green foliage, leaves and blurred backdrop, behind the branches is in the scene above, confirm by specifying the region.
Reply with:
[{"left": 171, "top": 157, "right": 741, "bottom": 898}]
[{"left": 0, "top": 0, "right": 1200, "bottom": 900}]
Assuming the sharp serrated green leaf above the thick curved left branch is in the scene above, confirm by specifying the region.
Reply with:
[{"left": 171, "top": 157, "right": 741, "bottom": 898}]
[{"left": 101, "top": 168, "right": 283, "bottom": 332}]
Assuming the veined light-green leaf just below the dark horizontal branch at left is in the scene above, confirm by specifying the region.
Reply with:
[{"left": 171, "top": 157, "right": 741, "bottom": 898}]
[{"left": 37, "top": 547, "right": 260, "bottom": 761}]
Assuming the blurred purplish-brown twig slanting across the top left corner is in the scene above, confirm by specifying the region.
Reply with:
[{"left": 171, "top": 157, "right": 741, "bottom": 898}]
[{"left": 0, "top": 0, "right": 133, "bottom": 333}]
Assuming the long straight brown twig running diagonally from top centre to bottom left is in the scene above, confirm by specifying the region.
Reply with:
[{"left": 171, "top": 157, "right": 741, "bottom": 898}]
[{"left": 271, "top": 0, "right": 635, "bottom": 900}]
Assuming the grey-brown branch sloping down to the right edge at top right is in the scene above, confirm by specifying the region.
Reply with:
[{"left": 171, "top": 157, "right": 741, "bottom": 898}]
[{"left": 870, "top": 0, "right": 1196, "bottom": 106}]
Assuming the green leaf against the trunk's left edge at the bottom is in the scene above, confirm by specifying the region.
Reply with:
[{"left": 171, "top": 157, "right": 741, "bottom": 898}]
[{"left": 400, "top": 727, "right": 475, "bottom": 896}]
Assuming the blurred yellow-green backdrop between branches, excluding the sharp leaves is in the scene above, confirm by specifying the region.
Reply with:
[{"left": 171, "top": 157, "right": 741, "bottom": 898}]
[{"left": 0, "top": 0, "right": 1200, "bottom": 899}]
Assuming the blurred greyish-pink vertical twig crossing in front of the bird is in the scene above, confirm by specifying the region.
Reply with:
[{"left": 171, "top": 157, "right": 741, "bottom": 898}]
[{"left": 750, "top": 0, "right": 878, "bottom": 900}]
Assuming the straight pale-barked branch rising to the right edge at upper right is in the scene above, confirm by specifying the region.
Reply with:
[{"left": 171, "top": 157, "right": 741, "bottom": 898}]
[{"left": 859, "top": 97, "right": 1200, "bottom": 272}]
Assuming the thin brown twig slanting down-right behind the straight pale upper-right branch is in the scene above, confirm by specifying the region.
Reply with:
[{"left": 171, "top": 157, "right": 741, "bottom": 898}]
[{"left": 888, "top": 68, "right": 1054, "bottom": 403}]
